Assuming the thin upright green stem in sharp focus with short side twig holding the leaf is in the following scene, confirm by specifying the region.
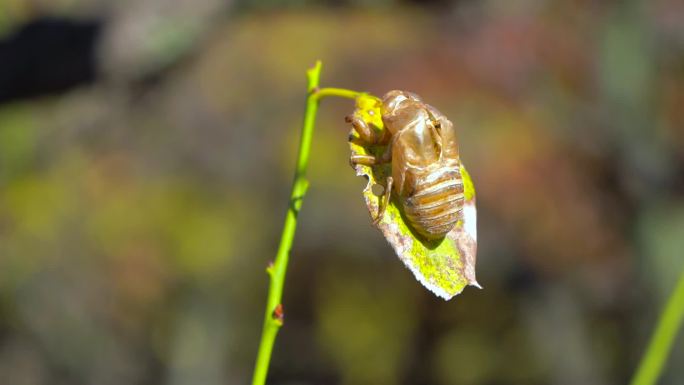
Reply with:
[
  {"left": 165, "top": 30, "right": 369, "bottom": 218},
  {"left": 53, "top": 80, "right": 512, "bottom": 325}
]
[{"left": 252, "top": 61, "right": 361, "bottom": 385}]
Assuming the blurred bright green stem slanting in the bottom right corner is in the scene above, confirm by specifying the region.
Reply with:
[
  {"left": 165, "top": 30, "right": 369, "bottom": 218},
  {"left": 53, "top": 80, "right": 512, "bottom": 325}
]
[{"left": 631, "top": 271, "right": 684, "bottom": 385}]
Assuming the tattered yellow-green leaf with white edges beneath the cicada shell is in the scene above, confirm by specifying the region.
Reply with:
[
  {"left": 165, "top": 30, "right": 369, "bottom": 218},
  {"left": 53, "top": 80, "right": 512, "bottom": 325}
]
[{"left": 350, "top": 95, "right": 480, "bottom": 300}]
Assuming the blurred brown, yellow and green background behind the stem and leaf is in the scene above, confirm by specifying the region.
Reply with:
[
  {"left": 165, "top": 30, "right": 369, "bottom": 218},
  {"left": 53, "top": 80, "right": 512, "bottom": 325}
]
[{"left": 0, "top": 0, "right": 684, "bottom": 385}]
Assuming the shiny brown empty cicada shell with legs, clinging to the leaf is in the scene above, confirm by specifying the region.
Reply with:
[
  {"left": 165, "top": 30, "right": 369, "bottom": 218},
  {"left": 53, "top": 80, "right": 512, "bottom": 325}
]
[{"left": 347, "top": 90, "right": 464, "bottom": 240}]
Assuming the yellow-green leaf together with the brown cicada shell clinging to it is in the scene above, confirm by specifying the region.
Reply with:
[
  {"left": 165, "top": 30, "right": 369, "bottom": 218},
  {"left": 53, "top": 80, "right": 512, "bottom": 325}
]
[{"left": 346, "top": 91, "right": 479, "bottom": 299}]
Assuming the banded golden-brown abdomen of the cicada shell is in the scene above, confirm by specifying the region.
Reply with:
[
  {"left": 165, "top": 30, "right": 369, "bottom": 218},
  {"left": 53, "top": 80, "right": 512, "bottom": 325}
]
[{"left": 403, "top": 166, "right": 464, "bottom": 239}]
